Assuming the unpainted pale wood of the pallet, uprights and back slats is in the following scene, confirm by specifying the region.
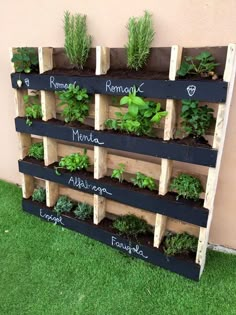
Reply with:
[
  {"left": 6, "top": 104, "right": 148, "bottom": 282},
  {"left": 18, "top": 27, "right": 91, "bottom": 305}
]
[{"left": 11, "top": 44, "right": 236, "bottom": 276}]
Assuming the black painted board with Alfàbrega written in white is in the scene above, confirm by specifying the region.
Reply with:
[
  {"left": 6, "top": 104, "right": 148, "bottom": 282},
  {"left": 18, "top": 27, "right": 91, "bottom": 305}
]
[{"left": 19, "top": 160, "right": 209, "bottom": 227}]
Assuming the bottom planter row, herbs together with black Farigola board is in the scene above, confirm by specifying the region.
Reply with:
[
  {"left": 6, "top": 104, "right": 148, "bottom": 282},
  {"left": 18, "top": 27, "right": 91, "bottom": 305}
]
[{"left": 22, "top": 195, "right": 200, "bottom": 280}]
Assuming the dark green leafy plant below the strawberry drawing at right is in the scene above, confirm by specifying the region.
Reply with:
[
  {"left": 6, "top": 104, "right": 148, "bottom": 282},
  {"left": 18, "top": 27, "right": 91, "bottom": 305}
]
[{"left": 181, "top": 100, "right": 214, "bottom": 137}]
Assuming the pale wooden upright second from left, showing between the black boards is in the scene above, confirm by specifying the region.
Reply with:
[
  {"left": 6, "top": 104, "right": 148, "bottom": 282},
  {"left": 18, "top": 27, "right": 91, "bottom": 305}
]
[{"left": 39, "top": 47, "right": 59, "bottom": 207}]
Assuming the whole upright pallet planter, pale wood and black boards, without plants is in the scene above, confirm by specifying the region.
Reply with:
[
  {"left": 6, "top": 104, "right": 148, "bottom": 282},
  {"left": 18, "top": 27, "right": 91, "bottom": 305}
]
[{"left": 12, "top": 44, "right": 236, "bottom": 280}]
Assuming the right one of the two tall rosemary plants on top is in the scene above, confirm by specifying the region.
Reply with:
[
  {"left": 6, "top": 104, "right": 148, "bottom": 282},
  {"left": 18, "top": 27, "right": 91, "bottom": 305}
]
[{"left": 125, "top": 11, "right": 155, "bottom": 70}]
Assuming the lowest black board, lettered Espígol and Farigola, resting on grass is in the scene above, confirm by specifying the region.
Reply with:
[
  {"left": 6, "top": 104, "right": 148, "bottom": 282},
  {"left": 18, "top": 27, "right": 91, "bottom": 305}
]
[{"left": 22, "top": 199, "right": 200, "bottom": 281}]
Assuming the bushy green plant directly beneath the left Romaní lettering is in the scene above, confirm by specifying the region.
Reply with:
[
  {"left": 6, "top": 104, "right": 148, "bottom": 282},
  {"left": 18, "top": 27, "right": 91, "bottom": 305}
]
[{"left": 56, "top": 84, "right": 89, "bottom": 123}]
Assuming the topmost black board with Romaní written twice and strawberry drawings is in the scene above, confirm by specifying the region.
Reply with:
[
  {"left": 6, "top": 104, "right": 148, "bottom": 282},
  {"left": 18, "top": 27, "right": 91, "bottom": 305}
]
[{"left": 11, "top": 73, "right": 227, "bottom": 103}]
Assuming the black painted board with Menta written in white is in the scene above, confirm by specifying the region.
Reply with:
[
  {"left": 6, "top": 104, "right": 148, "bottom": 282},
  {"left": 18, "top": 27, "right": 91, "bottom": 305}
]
[{"left": 15, "top": 117, "right": 217, "bottom": 167}]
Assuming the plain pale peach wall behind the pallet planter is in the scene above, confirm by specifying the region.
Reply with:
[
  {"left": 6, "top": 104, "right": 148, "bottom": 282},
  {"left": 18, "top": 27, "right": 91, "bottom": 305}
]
[{"left": 0, "top": 0, "right": 236, "bottom": 248}]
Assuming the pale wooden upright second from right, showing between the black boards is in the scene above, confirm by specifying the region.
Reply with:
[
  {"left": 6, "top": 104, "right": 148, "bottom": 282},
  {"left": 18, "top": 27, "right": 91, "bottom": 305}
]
[{"left": 154, "top": 45, "right": 182, "bottom": 247}]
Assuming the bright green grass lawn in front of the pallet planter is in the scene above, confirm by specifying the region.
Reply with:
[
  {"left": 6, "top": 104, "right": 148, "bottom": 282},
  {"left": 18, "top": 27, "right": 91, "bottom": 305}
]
[{"left": 0, "top": 181, "right": 236, "bottom": 315}]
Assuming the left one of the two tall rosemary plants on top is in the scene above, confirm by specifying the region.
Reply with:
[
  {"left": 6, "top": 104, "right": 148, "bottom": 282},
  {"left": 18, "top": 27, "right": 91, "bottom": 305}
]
[{"left": 64, "top": 11, "right": 92, "bottom": 69}]
